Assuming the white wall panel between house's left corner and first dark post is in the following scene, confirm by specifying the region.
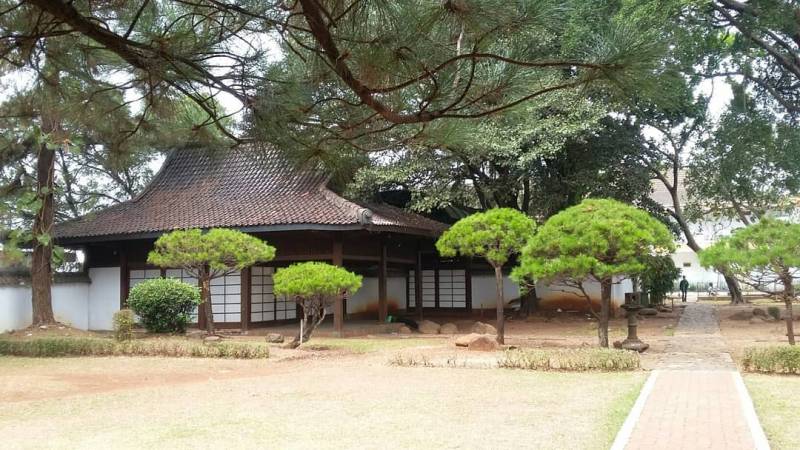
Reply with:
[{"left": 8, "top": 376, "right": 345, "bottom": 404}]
[{"left": 87, "top": 267, "right": 120, "bottom": 330}]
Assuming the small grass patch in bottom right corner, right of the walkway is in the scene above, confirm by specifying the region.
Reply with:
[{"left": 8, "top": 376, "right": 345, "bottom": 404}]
[{"left": 744, "top": 374, "right": 800, "bottom": 450}]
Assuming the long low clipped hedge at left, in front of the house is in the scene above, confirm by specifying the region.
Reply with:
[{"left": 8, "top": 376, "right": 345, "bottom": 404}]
[{"left": 0, "top": 337, "right": 269, "bottom": 359}]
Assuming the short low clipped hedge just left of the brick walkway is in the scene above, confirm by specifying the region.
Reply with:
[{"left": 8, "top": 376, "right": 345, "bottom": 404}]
[{"left": 499, "top": 348, "right": 639, "bottom": 372}]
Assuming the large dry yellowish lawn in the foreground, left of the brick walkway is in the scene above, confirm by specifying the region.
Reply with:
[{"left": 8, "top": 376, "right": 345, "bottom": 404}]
[{"left": 0, "top": 354, "right": 646, "bottom": 449}]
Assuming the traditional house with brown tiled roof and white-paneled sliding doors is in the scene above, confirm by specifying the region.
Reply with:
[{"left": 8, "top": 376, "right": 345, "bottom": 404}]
[{"left": 56, "top": 145, "right": 482, "bottom": 330}]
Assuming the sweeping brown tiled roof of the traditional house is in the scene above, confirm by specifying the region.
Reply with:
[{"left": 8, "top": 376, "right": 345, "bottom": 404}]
[{"left": 56, "top": 145, "right": 446, "bottom": 242}]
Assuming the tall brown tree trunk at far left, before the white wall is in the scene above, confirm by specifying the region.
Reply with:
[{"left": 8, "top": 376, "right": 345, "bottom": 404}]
[{"left": 31, "top": 144, "right": 55, "bottom": 326}]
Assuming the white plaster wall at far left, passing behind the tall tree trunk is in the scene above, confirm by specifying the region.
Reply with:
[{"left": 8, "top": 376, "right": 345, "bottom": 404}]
[{"left": 0, "top": 267, "right": 120, "bottom": 332}]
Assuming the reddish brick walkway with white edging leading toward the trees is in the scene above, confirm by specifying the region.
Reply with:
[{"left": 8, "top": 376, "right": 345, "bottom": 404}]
[{"left": 616, "top": 303, "right": 768, "bottom": 450}]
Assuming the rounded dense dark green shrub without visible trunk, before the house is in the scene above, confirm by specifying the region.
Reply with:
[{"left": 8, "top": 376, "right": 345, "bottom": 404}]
[{"left": 128, "top": 278, "right": 200, "bottom": 333}]
